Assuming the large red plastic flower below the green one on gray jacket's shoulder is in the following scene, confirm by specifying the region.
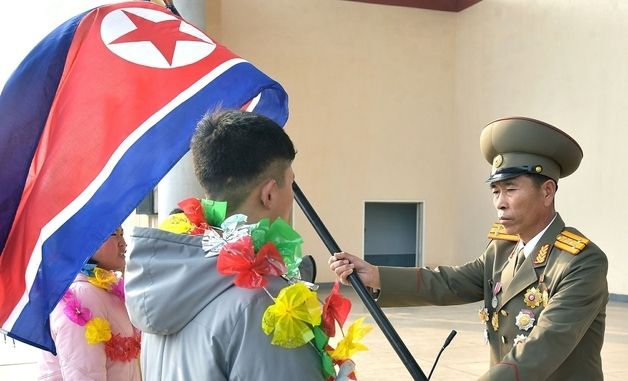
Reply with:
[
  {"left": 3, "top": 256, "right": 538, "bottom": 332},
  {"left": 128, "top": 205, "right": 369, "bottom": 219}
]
[{"left": 218, "top": 235, "right": 286, "bottom": 288}]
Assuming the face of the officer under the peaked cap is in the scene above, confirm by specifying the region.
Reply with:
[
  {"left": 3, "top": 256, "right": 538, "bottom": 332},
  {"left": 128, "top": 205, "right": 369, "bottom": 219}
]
[{"left": 491, "top": 176, "right": 555, "bottom": 242}]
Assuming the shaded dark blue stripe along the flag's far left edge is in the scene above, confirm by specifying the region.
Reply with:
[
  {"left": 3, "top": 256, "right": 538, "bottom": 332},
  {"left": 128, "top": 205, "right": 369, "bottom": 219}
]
[{"left": 0, "top": 13, "right": 85, "bottom": 253}]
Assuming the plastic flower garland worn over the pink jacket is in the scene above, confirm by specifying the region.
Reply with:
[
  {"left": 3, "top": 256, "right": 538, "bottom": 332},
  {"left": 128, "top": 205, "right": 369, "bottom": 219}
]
[{"left": 61, "top": 264, "right": 141, "bottom": 361}]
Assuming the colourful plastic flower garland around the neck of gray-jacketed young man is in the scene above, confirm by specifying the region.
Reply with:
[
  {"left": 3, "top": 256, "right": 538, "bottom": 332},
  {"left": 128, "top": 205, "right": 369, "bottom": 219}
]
[{"left": 160, "top": 198, "right": 372, "bottom": 381}]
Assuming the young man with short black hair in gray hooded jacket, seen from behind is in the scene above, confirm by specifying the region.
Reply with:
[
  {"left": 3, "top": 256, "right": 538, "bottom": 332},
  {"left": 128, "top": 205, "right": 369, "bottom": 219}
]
[{"left": 125, "top": 111, "right": 323, "bottom": 381}]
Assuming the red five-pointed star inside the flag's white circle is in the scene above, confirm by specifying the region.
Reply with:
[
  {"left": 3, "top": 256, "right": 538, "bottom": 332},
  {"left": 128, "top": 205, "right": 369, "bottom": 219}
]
[{"left": 111, "top": 11, "right": 206, "bottom": 65}]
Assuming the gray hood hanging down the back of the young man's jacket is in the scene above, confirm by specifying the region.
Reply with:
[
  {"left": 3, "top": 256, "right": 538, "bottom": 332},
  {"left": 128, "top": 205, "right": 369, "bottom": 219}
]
[{"left": 124, "top": 228, "right": 233, "bottom": 335}]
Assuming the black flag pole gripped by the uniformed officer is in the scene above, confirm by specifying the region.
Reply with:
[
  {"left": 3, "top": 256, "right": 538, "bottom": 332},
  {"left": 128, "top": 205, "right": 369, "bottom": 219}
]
[{"left": 292, "top": 182, "right": 427, "bottom": 381}]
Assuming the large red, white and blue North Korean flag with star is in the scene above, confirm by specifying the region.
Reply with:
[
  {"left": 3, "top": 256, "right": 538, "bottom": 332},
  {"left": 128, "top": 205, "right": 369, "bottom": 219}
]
[{"left": 0, "top": 1, "right": 288, "bottom": 353}]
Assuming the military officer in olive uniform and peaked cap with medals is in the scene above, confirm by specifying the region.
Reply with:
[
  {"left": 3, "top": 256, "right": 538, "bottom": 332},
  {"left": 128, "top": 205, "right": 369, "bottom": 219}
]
[{"left": 329, "top": 117, "right": 608, "bottom": 381}]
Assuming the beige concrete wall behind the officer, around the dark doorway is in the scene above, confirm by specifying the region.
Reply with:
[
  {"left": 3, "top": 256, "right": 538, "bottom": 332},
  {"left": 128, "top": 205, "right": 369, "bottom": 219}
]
[{"left": 207, "top": 0, "right": 628, "bottom": 294}]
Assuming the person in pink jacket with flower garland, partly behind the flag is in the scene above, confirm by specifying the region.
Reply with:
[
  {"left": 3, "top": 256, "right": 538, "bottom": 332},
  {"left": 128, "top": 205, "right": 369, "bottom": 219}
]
[{"left": 39, "top": 228, "right": 141, "bottom": 381}]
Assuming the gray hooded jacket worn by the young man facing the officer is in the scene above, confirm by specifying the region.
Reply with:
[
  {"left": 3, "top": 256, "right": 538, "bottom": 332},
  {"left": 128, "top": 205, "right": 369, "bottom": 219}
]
[{"left": 125, "top": 228, "right": 323, "bottom": 381}]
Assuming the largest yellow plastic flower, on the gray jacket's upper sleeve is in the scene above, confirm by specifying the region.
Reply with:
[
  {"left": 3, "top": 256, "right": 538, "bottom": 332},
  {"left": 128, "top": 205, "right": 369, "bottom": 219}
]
[{"left": 262, "top": 283, "right": 322, "bottom": 348}]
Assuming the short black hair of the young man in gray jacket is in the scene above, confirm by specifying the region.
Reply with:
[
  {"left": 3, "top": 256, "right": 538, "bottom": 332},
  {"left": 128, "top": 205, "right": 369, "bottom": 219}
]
[{"left": 191, "top": 110, "right": 296, "bottom": 210}]
